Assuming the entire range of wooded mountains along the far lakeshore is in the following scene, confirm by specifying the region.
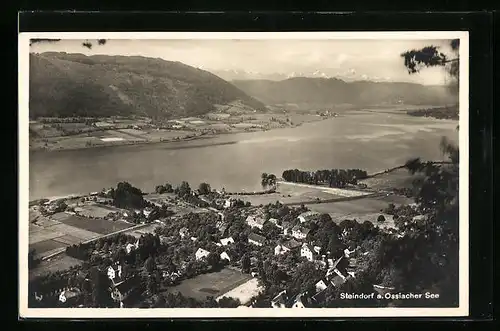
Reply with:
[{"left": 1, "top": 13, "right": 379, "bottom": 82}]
[{"left": 29, "top": 52, "right": 458, "bottom": 118}]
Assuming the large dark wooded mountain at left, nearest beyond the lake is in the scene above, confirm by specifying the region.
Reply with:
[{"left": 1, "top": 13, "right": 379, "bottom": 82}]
[{"left": 30, "top": 52, "right": 265, "bottom": 118}]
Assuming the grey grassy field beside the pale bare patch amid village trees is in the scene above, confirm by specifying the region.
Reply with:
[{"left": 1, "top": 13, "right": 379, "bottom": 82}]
[{"left": 167, "top": 268, "right": 251, "bottom": 300}]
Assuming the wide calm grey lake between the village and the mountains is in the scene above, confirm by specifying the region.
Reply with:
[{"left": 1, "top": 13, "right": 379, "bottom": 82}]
[{"left": 29, "top": 111, "right": 458, "bottom": 200}]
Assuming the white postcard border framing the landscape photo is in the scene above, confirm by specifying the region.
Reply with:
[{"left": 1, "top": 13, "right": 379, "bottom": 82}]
[{"left": 18, "top": 31, "right": 469, "bottom": 319}]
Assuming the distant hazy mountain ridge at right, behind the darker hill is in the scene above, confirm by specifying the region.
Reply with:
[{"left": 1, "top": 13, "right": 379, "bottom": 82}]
[{"left": 232, "top": 77, "right": 458, "bottom": 106}]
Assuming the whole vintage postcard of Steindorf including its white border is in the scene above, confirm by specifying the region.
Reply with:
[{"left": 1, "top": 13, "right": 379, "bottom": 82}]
[{"left": 19, "top": 32, "right": 469, "bottom": 318}]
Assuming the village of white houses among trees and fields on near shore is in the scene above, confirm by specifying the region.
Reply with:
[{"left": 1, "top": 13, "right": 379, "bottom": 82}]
[{"left": 30, "top": 175, "right": 419, "bottom": 308}]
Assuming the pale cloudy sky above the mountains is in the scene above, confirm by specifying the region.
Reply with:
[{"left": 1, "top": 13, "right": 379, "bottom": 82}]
[{"left": 31, "top": 39, "right": 458, "bottom": 85}]
